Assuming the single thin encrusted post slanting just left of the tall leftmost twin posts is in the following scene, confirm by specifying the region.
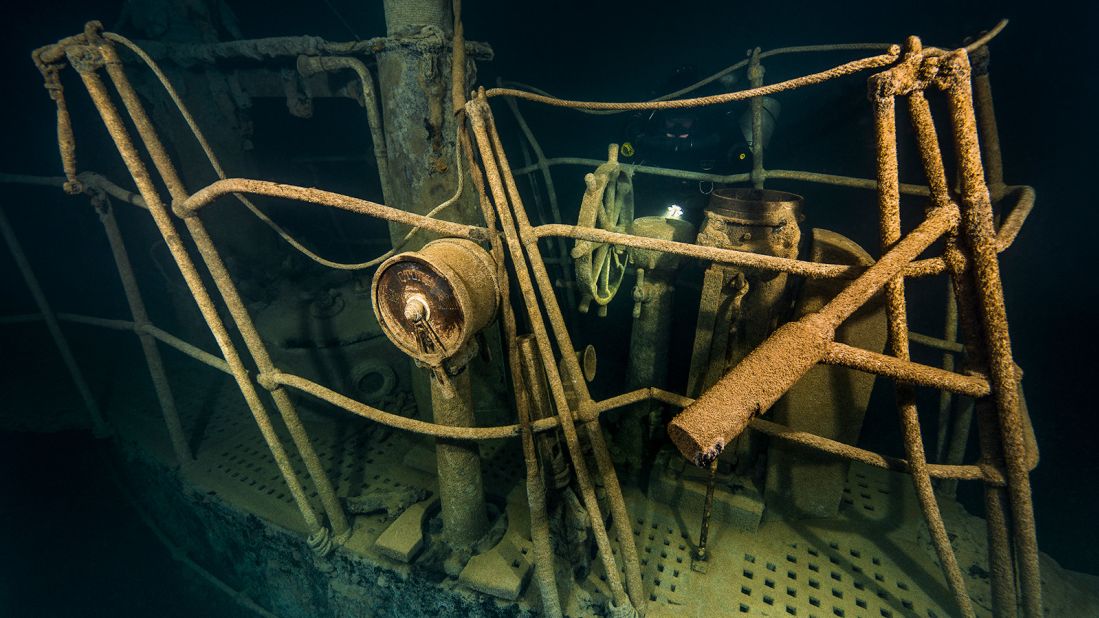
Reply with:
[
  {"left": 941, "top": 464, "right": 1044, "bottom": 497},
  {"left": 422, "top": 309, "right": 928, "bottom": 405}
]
[{"left": 92, "top": 194, "right": 193, "bottom": 472}]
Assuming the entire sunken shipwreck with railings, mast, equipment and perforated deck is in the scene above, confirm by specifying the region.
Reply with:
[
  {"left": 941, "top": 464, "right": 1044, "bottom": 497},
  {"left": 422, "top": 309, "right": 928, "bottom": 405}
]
[{"left": 0, "top": 0, "right": 1099, "bottom": 618}]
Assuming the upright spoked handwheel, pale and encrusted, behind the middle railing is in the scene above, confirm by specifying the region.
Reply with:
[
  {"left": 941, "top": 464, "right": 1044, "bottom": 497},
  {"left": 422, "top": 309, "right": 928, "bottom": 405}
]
[{"left": 571, "top": 144, "right": 633, "bottom": 317}]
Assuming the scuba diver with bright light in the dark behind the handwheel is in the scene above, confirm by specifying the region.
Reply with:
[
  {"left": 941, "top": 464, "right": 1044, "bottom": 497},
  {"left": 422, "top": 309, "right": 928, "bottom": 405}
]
[{"left": 619, "top": 66, "right": 781, "bottom": 223}]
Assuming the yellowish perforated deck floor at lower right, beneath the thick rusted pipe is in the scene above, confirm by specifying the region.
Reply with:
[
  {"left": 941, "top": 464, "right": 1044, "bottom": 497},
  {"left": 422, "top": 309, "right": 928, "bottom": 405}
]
[{"left": 596, "top": 466, "right": 983, "bottom": 618}]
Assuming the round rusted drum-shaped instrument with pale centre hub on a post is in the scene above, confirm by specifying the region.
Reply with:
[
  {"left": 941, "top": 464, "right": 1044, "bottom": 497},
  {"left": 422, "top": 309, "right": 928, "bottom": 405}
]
[{"left": 370, "top": 239, "right": 500, "bottom": 369}]
